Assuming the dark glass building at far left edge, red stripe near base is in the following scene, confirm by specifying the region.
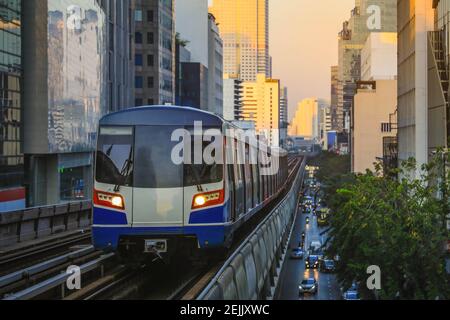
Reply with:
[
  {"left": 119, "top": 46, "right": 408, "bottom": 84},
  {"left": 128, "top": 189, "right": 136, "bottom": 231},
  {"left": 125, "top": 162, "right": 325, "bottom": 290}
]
[{"left": 0, "top": 0, "right": 26, "bottom": 212}]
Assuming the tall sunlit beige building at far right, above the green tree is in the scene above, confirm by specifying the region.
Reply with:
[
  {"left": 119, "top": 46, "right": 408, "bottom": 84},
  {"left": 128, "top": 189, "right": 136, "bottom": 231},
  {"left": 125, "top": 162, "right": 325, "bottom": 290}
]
[{"left": 398, "top": 0, "right": 450, "bottom": 172}]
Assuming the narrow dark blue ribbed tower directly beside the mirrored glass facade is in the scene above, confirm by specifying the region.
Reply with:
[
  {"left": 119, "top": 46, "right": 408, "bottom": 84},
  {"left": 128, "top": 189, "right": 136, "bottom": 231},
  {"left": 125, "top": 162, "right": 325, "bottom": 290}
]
[{"left": 101, "top": 0, "right": 134, "bottom": 112}]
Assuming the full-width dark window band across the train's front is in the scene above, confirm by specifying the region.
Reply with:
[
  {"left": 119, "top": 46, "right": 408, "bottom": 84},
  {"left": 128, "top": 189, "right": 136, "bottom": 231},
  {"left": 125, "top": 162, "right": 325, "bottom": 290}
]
[{"left": 96, "top": 126, "right": 223, "bottom": 189}]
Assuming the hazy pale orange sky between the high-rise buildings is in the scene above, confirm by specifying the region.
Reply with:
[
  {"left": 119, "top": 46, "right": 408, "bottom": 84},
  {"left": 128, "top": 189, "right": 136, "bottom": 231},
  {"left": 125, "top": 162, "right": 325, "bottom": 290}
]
[{"left": 269, "top": 0, "right": 355, "bottom": 120}]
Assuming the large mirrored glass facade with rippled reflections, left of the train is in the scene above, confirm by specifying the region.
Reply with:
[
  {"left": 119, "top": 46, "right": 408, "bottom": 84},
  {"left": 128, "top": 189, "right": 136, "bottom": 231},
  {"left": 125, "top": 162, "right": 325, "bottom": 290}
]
[{"left": 48, "top": 0, "right": 107, "bottom": 153}]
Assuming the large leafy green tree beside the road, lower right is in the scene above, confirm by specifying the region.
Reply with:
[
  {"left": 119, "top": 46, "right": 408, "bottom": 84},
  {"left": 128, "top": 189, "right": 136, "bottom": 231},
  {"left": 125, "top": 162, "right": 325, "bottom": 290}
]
[{"left": 326, "top": 159, "right": 450, "bottom": 299}]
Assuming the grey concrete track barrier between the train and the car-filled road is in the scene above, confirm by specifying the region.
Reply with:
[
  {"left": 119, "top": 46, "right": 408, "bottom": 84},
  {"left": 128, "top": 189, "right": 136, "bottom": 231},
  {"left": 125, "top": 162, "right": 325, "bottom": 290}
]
[{"left": 197, "top": 159, "right": 306, "bottom": 300}]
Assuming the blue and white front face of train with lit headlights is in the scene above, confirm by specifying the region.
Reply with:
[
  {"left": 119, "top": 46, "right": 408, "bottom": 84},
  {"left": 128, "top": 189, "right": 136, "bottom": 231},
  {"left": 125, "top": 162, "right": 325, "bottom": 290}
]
[{"left": 93, "top": 107, "right": 230, "bottom": 258}]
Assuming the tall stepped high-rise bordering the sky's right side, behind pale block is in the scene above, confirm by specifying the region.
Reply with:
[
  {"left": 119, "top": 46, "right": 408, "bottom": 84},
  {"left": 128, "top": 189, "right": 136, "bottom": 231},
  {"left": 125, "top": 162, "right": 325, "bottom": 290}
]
[{"left": 336, "top": 0, "right": 397, "bottom": 132}]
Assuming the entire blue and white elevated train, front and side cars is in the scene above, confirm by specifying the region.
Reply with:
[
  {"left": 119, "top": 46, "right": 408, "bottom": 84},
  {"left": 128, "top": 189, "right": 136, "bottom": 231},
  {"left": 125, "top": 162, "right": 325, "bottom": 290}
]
[{"left": 92, "top": 106, "right": 288, "bottom": 257}]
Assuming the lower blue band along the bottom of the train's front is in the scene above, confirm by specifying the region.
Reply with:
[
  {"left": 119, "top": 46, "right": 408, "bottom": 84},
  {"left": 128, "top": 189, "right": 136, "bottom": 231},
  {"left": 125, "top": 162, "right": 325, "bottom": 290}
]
[{"left": 92, "top": 226, "right": 230, "bottom": 250}]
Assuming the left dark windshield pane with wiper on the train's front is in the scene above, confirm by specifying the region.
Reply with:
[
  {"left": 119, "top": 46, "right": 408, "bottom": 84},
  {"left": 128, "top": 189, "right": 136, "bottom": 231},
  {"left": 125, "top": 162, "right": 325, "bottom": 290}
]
[{"left": 95, "top": 127, "right": 133, "bottom": 186}]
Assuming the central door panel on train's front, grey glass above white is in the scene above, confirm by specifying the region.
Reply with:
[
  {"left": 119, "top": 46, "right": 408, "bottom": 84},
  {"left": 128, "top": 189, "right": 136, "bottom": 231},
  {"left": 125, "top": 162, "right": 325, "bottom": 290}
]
[{"left": 133, "top": 126, "right": 184, "bottom": 227}]
